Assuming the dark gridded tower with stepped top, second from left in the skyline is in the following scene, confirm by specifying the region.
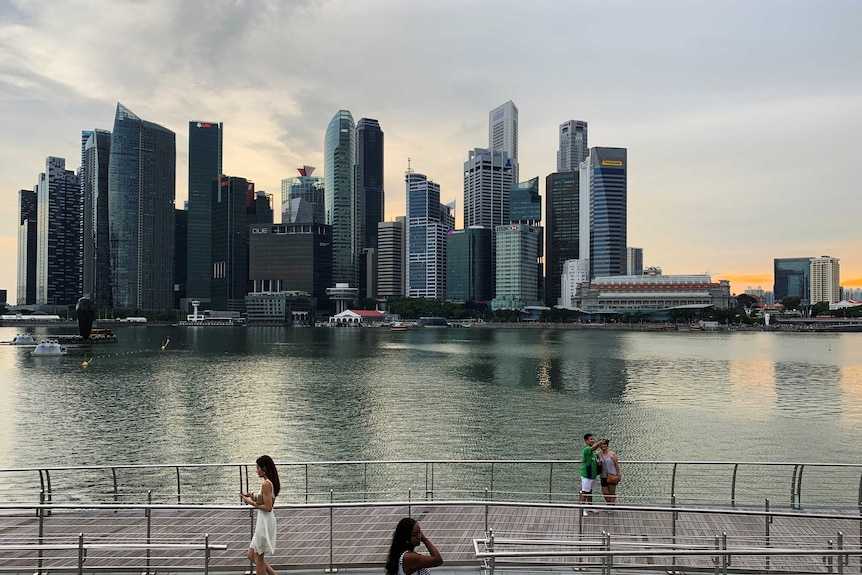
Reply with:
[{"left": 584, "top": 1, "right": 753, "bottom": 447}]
[{"left": 36, "top": 157, "right": 84, "bottom": 305}]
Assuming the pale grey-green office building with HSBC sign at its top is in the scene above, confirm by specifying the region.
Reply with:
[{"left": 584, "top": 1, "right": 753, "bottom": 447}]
[{"left": 491, "top": 224, "right": 542, "bottom": 309}]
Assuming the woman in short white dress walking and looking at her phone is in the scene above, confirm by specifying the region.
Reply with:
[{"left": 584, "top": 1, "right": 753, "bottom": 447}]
[{"left": 242, "top": 455, "right": 281, "bottom": 575}]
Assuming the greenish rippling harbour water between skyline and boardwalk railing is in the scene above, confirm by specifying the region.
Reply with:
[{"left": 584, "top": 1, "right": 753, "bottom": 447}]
[{"left": 0, "top": 326, "right": 862, "bottom": 468}]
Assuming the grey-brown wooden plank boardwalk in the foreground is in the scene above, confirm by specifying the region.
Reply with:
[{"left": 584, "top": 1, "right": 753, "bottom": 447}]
[{"left": 0, "top": 503, "right": 862, "bottom": 573}]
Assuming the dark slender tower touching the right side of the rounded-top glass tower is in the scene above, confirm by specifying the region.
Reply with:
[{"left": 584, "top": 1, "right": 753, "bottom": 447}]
[{"left": 356, "top": 118, "right": 384, "bottom": 248}]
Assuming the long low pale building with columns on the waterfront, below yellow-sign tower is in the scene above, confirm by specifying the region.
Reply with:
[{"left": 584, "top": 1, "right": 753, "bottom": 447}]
[{"left": 574, "top": 270, "right": 733, "bottom": 319}]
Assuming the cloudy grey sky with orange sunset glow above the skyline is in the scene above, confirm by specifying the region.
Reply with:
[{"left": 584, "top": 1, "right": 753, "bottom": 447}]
[{"left": 0, "top": 0, "right": 862, "bottom": 302}]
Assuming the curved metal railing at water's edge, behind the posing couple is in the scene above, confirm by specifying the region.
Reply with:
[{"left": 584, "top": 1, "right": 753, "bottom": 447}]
[{"left": 0, "top": 460, "right": 862, "bottom": 512}]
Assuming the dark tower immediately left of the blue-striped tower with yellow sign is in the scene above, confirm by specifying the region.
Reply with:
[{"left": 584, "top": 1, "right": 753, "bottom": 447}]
[{"left": 545, "top": 171, "right": 589, "bottom": 307}]
